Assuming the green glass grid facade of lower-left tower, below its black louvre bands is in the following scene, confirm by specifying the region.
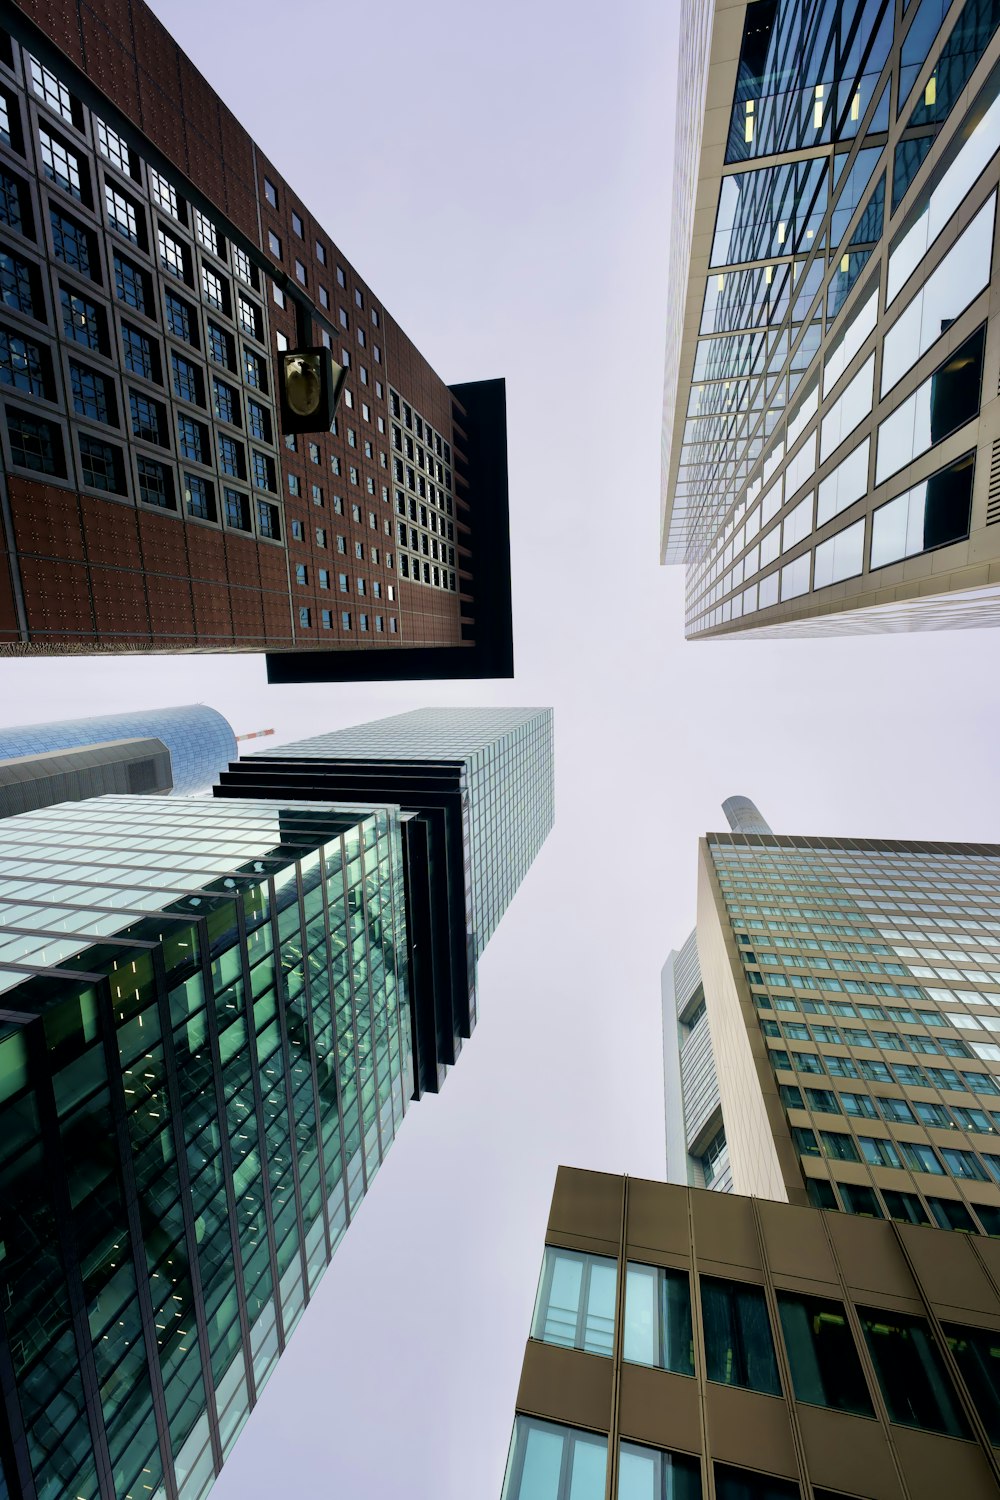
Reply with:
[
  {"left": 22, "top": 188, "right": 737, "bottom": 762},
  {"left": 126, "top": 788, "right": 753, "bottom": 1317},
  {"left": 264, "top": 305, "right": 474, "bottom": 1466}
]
[{"left": 0, "top": 798, "right": 412, "bottom": 1500}]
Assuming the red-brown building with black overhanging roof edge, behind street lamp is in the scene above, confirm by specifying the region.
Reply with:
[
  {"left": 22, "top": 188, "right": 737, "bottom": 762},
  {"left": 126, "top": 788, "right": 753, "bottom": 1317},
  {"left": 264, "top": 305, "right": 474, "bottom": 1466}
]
[{"left": 0, "top": 0, "right": 513, "bottom": 681}]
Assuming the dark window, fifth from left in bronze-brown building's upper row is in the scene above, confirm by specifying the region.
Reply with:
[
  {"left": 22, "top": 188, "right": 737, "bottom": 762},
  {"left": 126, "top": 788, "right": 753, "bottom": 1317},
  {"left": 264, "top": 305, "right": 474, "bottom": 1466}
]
[{"left": 858, "top": 1308, "right": 969, "bottom": 1437}]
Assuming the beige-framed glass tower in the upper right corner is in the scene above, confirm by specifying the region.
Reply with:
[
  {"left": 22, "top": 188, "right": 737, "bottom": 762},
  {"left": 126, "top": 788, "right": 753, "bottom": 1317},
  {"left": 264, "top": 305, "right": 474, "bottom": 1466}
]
[{"left": 661, "top": 0, "right": 1000, "bottom": 639}]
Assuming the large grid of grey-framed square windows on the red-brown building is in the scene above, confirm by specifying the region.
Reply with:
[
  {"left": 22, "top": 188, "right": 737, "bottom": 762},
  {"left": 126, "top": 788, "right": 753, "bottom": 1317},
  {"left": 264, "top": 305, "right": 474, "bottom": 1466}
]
[{"left": 0, "top": 44, "right": 283, "bottom": 540}]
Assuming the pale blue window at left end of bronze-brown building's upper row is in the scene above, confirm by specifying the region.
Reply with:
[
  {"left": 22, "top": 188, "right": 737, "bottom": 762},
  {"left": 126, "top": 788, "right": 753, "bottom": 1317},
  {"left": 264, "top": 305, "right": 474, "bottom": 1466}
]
[{"left": 530, "top": 1248, "right": 618, "bottom": 1355}]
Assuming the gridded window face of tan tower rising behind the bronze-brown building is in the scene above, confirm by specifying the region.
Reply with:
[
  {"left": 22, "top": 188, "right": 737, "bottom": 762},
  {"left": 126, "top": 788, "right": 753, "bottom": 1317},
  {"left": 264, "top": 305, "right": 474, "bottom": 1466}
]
[{"left": 709, "top": 836, "right": 1000, "bottom": 1235}]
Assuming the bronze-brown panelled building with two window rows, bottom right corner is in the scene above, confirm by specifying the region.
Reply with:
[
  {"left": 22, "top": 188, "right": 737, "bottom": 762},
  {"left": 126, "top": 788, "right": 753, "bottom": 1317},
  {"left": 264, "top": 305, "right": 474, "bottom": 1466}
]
[{"left": 504, "top": 1167, "right": 1000, "bottom": 1500}]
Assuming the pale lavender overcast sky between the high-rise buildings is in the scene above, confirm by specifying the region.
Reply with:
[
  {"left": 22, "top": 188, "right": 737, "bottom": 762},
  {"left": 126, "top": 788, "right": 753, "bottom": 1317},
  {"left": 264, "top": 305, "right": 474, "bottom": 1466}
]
[{"left": 0, "top": 0, "right": 1000, "bottom": 1500}]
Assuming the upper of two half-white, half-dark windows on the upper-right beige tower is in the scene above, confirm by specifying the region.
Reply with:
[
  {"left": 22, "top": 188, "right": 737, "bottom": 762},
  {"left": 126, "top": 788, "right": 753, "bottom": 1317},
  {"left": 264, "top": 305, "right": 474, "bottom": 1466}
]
[{"left": 876, "top": 324, "right": 987, "bottom": 485}]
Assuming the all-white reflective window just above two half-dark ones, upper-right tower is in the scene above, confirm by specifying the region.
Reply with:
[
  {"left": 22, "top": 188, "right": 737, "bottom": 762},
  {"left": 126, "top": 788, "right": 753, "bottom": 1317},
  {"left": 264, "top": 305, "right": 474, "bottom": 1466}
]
[{"left": 882, "top": 192, "right": 997, "bottom": 396}]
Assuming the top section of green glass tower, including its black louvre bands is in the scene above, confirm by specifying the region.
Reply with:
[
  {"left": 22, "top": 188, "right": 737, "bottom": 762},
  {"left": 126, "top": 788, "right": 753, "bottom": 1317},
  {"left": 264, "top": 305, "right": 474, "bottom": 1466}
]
[{"left": 216, "top": 708, "right": 555, "bottom": 1094}]
